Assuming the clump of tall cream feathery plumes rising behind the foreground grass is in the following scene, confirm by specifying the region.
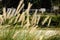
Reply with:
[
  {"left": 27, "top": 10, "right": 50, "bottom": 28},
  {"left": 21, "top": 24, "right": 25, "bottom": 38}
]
[{"left": 0, "top": 0, "right": 51, "bottom": 28}]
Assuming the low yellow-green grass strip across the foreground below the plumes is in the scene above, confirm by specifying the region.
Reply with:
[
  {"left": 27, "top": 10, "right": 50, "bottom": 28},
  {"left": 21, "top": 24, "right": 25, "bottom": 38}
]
[{"left": 0, "top": 25, "right": 60, "bottom": 40}]
